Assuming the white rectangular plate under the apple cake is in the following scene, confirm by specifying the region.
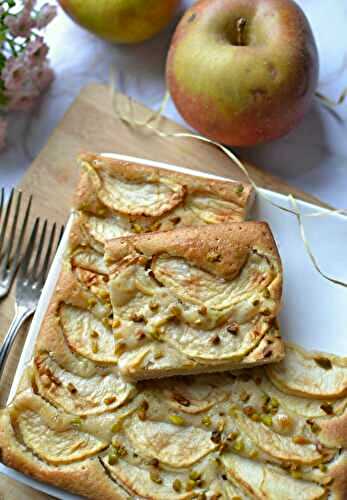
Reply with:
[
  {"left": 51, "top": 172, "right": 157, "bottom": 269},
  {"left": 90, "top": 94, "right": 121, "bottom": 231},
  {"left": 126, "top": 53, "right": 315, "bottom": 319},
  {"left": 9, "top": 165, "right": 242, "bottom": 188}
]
[{"left": 0, "top": 154, "right": 347, "bottom": 500}]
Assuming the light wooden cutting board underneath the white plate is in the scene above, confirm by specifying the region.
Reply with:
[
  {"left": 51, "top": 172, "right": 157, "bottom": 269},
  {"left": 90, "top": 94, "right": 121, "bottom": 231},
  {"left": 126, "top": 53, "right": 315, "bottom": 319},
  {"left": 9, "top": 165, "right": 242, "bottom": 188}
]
[{"left": 0, "top": 84, "right": 323, "bottom": 500}]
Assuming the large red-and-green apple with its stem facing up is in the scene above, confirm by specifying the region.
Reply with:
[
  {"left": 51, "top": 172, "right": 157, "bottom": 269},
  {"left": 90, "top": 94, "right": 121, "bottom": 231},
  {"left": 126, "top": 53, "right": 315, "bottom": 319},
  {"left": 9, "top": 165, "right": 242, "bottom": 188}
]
[{"left": 166, "top": 0, "right": 318, "bottom": 146}]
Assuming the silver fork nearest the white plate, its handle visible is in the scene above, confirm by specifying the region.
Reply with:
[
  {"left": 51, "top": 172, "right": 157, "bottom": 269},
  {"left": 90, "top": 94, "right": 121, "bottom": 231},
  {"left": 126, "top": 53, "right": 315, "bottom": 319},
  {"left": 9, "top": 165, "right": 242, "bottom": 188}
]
[{"left": 0, "top": 218, "right": 64, "bottom": 377}]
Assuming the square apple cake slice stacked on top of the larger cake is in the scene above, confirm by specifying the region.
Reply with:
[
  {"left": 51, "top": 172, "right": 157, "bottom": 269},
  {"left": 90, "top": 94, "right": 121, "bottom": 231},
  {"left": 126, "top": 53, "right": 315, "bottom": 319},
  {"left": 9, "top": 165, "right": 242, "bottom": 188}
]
[{"left": 106, "top": 222, "right": 284, "bottom": 381}]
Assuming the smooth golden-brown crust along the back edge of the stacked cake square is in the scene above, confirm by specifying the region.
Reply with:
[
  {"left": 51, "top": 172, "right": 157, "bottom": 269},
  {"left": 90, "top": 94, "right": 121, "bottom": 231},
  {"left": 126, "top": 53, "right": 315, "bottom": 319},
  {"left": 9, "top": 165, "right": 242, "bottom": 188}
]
[{"left": 106, "top": 222, "right": 282, "bottom": 284}]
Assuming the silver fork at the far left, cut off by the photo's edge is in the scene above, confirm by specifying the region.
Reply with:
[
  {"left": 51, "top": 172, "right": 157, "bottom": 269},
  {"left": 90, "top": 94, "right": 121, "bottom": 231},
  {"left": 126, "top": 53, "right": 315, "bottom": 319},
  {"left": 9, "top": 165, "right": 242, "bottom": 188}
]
[{"left": 0, "top": 188, "right": 32, "bottom": 299}]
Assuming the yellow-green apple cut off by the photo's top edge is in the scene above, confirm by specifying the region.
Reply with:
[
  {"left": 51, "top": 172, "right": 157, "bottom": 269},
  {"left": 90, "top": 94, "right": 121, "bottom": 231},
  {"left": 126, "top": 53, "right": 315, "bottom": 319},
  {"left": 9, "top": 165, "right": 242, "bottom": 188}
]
[{"left": 58, "top": 0, "right": 181, "bottom": 43}]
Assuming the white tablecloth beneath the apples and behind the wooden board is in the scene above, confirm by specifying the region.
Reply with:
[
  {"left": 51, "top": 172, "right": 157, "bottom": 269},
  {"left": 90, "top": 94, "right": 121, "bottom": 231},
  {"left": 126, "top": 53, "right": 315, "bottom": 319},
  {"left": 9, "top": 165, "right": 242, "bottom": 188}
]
[{"left": 0, "top": 0, "right": 347, "bottom": 208}]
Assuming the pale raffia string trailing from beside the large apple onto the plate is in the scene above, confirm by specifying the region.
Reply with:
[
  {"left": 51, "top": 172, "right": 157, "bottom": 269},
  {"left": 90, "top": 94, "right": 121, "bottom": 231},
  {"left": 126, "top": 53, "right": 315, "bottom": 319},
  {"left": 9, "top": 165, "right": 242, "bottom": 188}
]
[{"left": 110, "top": 71, "right": 347, "bottom": 288}]
